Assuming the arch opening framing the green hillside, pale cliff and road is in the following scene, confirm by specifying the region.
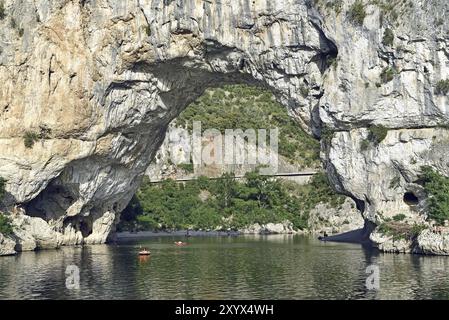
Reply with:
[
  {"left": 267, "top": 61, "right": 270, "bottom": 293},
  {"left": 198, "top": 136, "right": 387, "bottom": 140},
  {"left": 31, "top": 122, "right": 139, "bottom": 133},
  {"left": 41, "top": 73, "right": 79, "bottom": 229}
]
[{"left": 118, "top": 83, "right": 361, "bottom": 233}]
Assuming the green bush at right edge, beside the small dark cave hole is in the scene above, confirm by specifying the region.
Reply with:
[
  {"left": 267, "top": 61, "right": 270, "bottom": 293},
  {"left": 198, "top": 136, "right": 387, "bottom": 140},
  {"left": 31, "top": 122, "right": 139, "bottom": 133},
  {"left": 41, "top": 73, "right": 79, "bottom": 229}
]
[{"left": 421, "top": 166, "right": 449, "bottom": 225}]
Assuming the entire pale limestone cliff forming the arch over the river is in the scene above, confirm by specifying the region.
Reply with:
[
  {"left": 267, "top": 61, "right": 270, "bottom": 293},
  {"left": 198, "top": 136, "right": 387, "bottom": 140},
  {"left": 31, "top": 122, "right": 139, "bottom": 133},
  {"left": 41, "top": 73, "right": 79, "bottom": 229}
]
[{"left": 0, "top": 0, "right": 449, "bottom": 255}]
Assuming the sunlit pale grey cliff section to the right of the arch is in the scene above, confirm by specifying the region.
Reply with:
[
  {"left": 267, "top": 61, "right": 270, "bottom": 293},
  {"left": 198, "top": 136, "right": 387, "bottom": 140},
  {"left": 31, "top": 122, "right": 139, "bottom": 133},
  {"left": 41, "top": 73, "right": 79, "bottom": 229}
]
[{"left": 319, "top": 0, "right": 449, "bottom": 226}]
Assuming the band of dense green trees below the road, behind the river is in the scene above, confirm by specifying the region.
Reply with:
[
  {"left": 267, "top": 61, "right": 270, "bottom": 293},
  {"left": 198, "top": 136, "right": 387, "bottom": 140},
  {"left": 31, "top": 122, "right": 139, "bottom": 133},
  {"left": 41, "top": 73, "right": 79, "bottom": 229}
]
[{"left": 119, "top": 172, "right": 344, "bottom": 230}]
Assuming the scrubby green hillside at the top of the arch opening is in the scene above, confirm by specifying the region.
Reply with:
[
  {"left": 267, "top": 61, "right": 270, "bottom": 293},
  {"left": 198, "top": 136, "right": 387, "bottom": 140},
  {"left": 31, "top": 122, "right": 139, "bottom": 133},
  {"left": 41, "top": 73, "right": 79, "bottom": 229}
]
[{"left": 176, "top": 84, "right": 320, "bottom": 168}]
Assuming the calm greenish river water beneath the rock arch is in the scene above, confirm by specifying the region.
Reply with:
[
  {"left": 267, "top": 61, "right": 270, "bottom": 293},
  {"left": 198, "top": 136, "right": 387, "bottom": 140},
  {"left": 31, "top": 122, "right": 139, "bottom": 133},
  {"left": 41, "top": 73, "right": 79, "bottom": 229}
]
[{"left": 0, "top": 236, "right": 449, "bottom": 299}]
